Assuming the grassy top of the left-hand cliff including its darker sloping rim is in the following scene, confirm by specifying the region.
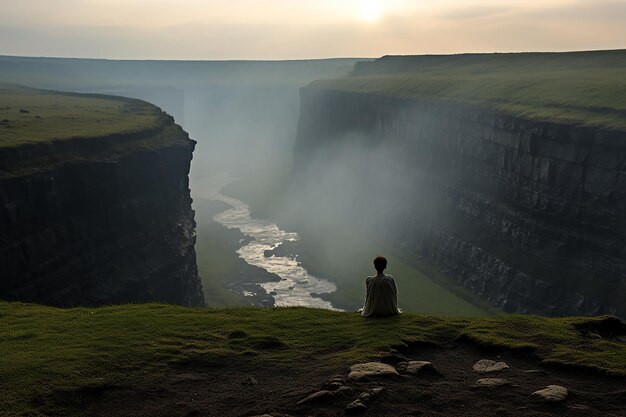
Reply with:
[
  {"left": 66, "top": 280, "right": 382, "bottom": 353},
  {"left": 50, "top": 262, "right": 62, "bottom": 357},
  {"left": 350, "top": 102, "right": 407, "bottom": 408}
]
[{"left": 0, "top": 85, "right": 188, "bottom": 177}]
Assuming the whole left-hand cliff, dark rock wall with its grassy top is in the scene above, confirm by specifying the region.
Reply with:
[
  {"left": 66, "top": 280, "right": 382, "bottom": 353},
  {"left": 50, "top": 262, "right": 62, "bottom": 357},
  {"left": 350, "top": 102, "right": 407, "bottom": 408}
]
[{"left": 0, "top": 89, "right": 203, "bottom": 306}]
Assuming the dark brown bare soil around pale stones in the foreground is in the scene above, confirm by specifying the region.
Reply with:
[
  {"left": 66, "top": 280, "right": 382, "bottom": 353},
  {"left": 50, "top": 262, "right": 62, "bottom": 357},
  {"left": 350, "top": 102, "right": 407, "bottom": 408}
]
[{"left": 46, "top": 343, "right": 626, "bottom": 417}]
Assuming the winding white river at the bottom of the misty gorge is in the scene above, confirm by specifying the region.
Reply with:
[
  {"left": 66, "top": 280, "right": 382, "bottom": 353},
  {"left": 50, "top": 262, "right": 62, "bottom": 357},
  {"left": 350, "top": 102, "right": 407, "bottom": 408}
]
[{"left": 192, "top": 174, "right": 337, "bottom": 310}]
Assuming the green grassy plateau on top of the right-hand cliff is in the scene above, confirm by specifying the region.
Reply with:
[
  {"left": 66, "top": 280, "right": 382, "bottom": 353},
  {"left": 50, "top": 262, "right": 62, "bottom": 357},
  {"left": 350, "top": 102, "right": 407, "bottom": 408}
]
[{"left": 312, "top": 50, "right": 626, "bottom": 129}]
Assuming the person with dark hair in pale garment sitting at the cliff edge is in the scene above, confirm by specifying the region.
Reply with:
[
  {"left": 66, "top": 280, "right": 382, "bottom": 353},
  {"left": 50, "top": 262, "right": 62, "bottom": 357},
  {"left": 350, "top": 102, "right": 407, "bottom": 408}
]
[{"left": 358, "top": 256, "right": 402, "bottom": 317}]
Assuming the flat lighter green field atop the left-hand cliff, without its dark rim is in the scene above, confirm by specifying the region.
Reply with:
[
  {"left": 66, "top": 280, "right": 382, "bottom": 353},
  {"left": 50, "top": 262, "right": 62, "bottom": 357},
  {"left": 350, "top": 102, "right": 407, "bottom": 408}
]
[{"left": 0, "top": 86, "right": 161, "bottom": 149}]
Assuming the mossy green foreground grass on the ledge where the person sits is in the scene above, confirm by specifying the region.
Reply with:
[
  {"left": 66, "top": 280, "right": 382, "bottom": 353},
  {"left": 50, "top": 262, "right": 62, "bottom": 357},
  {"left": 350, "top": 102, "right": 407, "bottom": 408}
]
[{"left": 0, "top": 302, "right": 626, "bottom": 415}]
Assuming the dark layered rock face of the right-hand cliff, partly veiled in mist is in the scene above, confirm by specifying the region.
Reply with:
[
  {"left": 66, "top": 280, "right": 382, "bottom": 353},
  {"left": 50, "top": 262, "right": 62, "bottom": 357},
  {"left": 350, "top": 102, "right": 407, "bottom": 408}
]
[{"left": 295, "top": 87, "right": 626, "bottom": 316}]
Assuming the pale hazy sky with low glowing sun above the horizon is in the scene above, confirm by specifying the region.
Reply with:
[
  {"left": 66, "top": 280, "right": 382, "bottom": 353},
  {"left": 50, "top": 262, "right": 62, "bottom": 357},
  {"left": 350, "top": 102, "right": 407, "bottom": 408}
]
[{"left": 0, "top": 0, "right": 626, "bottom": 60}]
